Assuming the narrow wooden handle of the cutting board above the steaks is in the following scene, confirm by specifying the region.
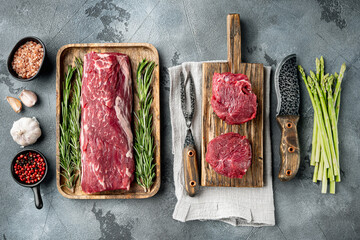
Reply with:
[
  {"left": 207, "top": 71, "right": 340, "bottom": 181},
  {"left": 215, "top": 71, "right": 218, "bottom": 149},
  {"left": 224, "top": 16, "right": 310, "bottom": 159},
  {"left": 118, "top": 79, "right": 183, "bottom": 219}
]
[{"left": 227, "top": 14, "right": 241, "bottom": 73}]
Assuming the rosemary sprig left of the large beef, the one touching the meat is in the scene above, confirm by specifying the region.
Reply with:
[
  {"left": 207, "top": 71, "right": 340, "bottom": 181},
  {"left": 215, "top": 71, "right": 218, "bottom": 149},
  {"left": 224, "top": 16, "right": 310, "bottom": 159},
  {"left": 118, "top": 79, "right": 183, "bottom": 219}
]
[{"left": 70, "top": 58, "right": 83, "bottom": 182}]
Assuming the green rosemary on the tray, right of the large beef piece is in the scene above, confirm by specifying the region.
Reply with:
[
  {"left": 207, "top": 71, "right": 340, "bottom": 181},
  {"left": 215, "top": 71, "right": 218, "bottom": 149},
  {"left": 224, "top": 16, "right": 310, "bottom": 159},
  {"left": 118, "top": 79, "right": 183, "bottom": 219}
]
[{"left": 134, "top": 59, "right": 156, "bottom": 192}]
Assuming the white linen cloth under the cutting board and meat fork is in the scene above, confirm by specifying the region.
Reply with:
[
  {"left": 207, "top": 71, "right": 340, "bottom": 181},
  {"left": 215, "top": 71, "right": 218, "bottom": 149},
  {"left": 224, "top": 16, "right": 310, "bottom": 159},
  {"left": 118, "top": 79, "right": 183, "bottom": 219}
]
[{"left": 169, "top": 62, "right": 275, "bottom": 227}]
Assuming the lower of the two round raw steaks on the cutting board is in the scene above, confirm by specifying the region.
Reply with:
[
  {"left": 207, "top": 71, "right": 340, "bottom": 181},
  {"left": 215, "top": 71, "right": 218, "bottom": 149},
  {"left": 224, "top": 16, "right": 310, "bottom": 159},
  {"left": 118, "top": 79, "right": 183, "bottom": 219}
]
[{"left": 206, "top": 133, "right": 252, "bottom": 178}]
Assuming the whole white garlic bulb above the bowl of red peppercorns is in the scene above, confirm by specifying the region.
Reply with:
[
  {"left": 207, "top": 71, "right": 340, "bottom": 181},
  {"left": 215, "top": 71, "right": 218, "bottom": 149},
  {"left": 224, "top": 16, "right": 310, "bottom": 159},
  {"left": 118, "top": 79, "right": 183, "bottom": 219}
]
[{"left": 10, "top": 117, "right": 41, "bottom": 146}]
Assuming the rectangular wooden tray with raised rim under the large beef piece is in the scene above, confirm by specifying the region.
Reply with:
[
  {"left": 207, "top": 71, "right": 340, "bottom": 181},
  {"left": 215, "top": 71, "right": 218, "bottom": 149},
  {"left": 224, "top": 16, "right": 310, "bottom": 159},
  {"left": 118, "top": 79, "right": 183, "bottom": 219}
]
[{"left": 56, "top": 43, "right": 160, "bottom": 199}]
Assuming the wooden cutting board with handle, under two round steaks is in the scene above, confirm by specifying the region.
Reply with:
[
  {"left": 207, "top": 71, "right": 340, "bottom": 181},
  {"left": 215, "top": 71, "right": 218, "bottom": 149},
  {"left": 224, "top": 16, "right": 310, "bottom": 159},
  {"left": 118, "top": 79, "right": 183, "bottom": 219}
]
[{"left": 201, "top": 14, "right": 264, "bottom": 187}]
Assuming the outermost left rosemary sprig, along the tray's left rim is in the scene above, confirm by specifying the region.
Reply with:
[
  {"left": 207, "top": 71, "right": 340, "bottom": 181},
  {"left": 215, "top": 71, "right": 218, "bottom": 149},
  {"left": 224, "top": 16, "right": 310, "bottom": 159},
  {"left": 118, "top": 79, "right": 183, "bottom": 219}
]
[{"left": 59, "top": 65, "right": 75, "bottom": 191}]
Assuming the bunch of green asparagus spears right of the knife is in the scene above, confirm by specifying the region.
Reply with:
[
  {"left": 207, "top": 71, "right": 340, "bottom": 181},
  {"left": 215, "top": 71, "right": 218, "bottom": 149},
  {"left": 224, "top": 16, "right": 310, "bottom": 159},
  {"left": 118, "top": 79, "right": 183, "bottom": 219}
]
[{"left": 298, "top": 56, "right": 346, "bottom": 194}]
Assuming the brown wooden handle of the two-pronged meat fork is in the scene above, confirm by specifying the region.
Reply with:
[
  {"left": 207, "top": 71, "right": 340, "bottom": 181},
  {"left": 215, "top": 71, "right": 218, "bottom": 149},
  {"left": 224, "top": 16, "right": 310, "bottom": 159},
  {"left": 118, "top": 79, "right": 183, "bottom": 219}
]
[{"left": 183, "top": 145, "right": 200, "bottom": 197}]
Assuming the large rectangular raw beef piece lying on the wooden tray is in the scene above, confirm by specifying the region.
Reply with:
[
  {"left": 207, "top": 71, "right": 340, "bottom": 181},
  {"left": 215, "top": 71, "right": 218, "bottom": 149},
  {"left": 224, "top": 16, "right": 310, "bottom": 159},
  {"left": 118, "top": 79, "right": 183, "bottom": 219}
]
[{"left": 80, "top": 53, "right": 135, "bottom": 193}]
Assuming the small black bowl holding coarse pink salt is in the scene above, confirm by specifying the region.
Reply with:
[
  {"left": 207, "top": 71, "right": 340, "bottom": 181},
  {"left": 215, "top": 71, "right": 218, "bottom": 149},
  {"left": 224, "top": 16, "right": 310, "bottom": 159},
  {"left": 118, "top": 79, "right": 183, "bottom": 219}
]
[{"left": 7, "top": 37, "right": 46, "bottom": 82}]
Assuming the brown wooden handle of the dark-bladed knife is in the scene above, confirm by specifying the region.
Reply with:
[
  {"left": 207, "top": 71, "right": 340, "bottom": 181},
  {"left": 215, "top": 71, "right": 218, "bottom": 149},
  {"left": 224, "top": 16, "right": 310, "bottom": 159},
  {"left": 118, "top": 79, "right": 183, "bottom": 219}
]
[{"left": 276, "top": 116, "right": 300, "bottom": 181}]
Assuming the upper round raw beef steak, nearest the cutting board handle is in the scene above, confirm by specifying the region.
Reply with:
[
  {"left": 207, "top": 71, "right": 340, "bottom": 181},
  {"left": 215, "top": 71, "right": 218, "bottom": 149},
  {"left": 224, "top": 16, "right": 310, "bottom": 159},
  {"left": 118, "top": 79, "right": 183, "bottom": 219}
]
[{"left": 211, "top": 72, "right": 257, "bottom": 125}]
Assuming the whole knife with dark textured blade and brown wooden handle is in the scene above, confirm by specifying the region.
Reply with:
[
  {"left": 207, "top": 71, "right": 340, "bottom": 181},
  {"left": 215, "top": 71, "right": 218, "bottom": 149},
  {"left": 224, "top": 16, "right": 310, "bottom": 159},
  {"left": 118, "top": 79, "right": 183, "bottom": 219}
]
[{"left": 275, "top": 54, "right": 300, "bottom": 181}]
